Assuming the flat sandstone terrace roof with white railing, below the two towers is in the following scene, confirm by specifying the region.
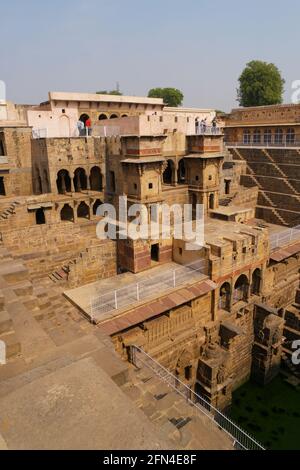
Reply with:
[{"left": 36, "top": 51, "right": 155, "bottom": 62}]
[{"left": 64, "top": 260, "right": 208, "bottom": 323}]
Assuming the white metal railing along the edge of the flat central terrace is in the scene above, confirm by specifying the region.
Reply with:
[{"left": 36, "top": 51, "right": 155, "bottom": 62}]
[{"left": 90, "top": 260, "right": 207, "bottom": 319}]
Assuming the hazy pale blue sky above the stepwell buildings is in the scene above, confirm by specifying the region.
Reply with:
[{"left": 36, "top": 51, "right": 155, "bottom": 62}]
[{"left": 0, "top": 0, "right": 300, "bottom": 111}]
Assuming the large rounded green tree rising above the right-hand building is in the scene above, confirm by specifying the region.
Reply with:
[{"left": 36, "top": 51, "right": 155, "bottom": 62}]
[{"left": 238, "top": 60, "right": 285, "bottom": 107}]
